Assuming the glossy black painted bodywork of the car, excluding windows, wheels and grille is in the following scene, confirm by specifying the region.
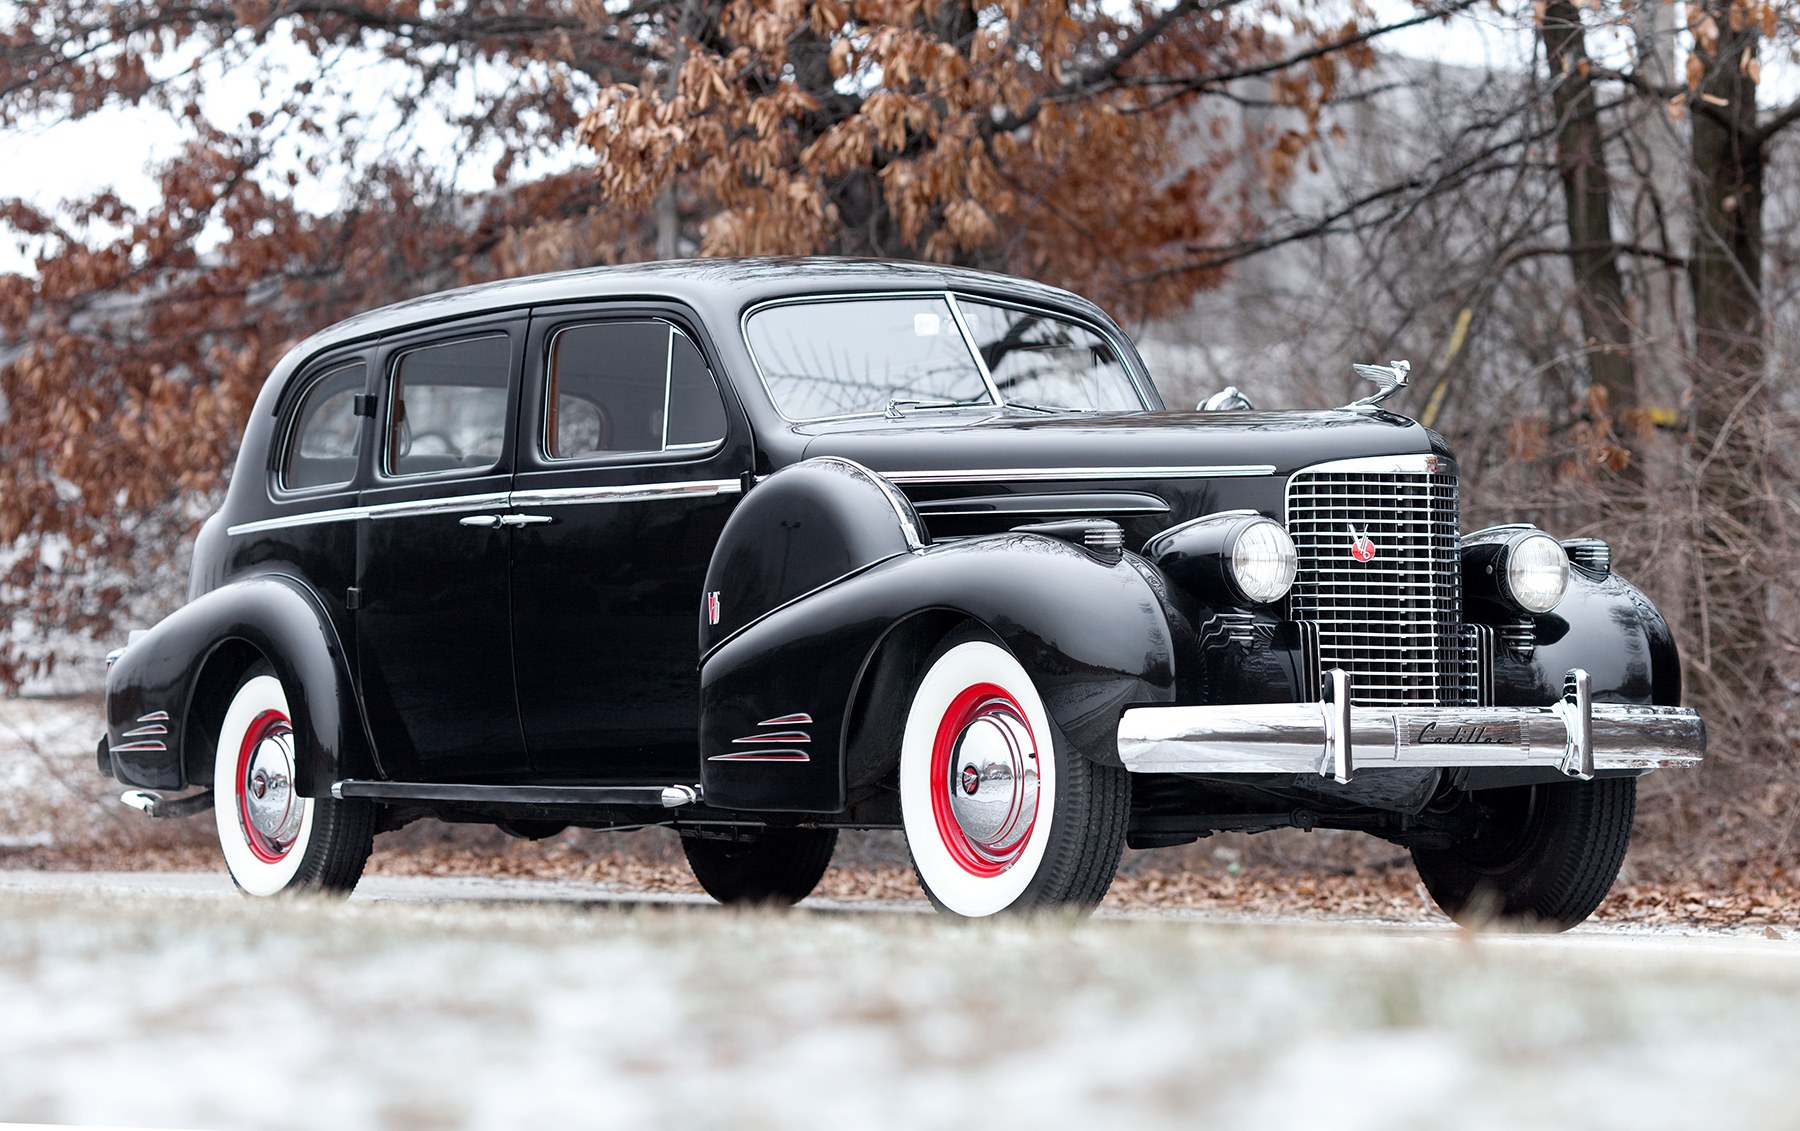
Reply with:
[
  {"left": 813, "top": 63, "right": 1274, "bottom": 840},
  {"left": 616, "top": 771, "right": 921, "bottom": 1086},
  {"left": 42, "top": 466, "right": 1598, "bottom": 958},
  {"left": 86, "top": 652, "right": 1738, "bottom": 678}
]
[{"left": 108, "top": 261, "right": 1679, "bottom": 839}]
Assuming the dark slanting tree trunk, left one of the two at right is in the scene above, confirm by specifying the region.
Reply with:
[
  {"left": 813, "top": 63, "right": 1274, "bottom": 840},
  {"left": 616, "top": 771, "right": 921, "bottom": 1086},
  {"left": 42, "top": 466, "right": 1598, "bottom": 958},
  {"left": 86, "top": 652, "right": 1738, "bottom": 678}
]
[{"left": 1539, "top": 0, "right": 1638, "bottom": 425}]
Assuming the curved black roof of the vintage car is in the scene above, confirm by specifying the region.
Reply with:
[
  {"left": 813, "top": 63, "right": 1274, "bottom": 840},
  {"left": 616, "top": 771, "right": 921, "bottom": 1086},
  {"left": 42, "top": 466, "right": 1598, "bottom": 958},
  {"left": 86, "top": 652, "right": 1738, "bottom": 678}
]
[{"left": 293, "top": 258, "right": 1103, "bottom": 357}]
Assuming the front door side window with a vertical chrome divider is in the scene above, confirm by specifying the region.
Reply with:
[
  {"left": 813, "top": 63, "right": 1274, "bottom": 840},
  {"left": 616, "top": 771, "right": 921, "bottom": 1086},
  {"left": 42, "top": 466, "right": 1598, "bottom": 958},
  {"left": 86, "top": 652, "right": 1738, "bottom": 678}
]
[{"left": 544, "top": 321, "right": 725, "bottom": 459}]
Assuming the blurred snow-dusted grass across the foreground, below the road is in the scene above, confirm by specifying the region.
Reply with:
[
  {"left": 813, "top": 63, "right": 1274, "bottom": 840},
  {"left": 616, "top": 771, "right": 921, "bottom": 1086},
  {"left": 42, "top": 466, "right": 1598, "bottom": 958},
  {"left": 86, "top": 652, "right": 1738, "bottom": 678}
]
[{"left": 0, "top": 877, "right": 1800, "bottom": 1131}]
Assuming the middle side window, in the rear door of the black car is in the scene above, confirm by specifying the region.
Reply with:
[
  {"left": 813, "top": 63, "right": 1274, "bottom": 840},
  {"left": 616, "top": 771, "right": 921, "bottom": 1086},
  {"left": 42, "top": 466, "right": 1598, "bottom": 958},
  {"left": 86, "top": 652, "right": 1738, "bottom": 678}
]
[{"left": 382, "top": 333, "right": 513, "bottom": 475}]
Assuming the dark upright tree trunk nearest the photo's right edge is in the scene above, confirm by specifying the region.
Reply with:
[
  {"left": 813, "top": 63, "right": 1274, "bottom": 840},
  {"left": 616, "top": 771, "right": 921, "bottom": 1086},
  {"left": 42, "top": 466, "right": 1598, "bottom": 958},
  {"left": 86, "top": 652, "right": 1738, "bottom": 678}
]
[{"left": 1688, "top": 0, "right": 1778, "bottom": 755}]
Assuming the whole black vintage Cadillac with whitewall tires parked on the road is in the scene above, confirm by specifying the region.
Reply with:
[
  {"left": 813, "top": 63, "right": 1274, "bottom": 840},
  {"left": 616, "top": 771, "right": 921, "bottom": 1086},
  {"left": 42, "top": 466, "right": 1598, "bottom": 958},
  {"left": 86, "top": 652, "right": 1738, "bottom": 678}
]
[{"left": 99, "top": 261, "right": 1705, "bottom": 926}]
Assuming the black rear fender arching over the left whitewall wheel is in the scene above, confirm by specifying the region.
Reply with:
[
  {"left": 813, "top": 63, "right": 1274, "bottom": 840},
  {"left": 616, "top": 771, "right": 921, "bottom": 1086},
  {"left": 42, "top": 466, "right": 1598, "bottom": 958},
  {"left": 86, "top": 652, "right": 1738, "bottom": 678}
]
[{"left": 106, "top": 575, "right": 374, "bottom": 798}]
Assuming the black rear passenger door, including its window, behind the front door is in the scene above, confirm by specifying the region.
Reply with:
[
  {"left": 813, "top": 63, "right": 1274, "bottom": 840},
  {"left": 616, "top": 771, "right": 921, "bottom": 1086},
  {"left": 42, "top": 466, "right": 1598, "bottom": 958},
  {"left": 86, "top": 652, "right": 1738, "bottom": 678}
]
[{"left": 356, "top": 317, "right": 529, "bottom": 782}]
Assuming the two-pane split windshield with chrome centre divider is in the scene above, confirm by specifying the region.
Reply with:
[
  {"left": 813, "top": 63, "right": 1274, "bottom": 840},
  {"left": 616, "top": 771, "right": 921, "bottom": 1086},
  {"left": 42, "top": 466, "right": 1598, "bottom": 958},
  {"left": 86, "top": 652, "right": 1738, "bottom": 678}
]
[{"left": 745, "top": 295, "right": 1145, "bottom": 421}]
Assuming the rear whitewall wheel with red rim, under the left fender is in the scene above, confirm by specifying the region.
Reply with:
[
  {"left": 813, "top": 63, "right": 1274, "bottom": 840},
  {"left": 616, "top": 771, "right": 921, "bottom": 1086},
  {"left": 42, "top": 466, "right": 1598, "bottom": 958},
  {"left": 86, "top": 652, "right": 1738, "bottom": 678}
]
[{"left": 212, "top": 666, "right": 374, "bottom": 895}]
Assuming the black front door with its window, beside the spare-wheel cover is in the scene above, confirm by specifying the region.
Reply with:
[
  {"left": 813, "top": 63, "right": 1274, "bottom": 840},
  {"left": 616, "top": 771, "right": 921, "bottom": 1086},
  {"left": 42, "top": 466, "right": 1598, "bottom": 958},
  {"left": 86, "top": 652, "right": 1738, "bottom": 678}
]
[{"left": 513, "top": 306, "right": 752, "bottom": 782}]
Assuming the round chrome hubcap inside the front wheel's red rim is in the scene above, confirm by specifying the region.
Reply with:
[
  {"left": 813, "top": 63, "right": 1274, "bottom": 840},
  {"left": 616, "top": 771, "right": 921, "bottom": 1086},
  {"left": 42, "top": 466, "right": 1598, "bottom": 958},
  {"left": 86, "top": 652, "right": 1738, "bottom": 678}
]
[{"left": 950, "top": 701, "right": 1037, "bottom": 863}]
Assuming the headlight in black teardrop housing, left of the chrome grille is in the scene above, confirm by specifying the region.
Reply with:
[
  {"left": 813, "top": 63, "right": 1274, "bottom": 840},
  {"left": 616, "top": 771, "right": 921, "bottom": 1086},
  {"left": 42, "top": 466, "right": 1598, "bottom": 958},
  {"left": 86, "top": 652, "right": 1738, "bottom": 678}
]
[{"left": 1143, "top": 510, "right": 1300, "bottom": 605}]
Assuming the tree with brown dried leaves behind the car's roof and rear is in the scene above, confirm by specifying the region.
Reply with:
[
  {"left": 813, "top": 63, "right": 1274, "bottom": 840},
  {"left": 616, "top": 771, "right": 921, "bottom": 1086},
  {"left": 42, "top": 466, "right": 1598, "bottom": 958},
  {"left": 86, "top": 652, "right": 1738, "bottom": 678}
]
[{"left": 0, "top": 0, "right": 1370, "bottom": 686}]
